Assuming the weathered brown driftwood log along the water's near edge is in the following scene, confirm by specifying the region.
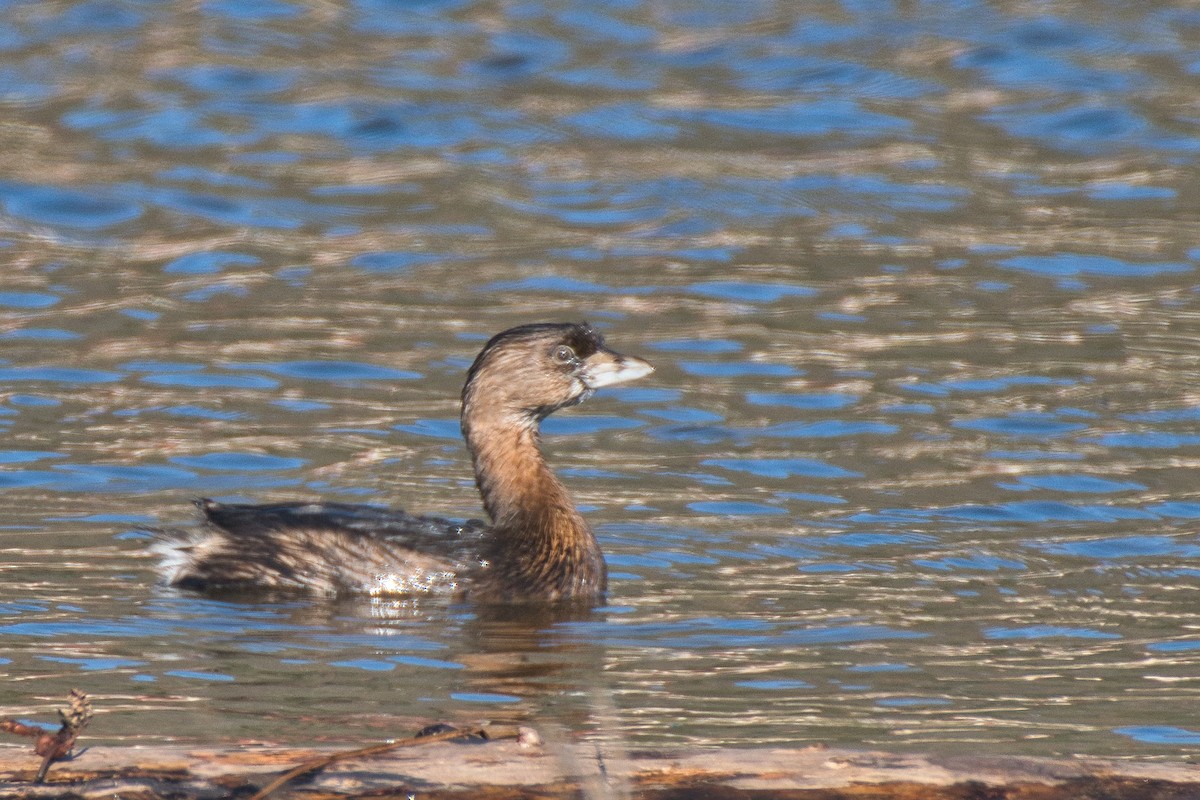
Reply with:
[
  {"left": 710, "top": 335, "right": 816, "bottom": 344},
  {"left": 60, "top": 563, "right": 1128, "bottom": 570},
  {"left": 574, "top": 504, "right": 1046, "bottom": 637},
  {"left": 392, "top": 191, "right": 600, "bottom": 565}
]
[{"left": 0, "top": 734, "right": 1200, "bottom": 800}]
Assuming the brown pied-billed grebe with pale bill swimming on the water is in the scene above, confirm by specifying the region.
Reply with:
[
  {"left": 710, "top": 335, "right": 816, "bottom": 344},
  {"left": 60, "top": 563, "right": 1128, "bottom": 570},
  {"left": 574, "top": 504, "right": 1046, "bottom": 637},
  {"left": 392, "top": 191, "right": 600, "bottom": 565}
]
[{"left": 156, "top": 323, "right": 654, "bottom": 602}]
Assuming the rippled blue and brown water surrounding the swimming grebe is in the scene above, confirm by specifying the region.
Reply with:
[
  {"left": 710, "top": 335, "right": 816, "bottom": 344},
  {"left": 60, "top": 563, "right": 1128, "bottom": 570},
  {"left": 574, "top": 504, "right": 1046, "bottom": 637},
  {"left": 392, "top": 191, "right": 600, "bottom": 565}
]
[{"left": 0, "top": 0, "right": 1200, "bottom": 757}]
